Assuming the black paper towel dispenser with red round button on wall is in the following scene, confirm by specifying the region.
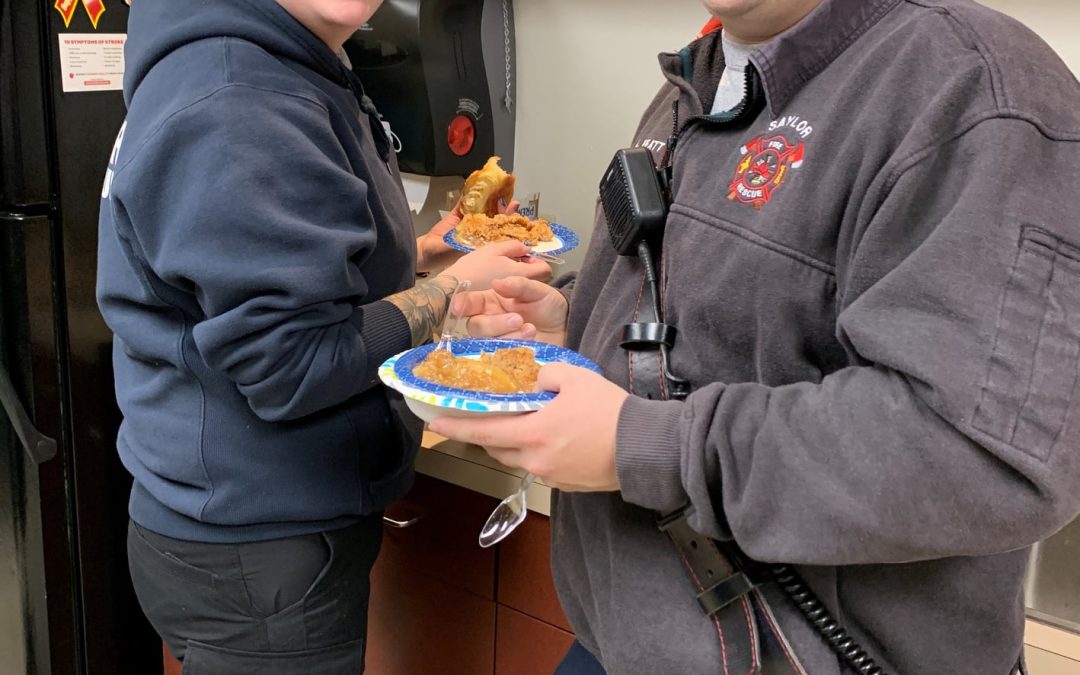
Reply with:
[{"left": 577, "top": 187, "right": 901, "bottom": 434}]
[{"left": 345, "top": 0, "right": 516, "bottom": 176}]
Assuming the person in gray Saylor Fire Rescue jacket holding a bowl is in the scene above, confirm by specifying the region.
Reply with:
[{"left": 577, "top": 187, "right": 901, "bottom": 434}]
[{"left": 432, "top": 0, "right": 1080, "bottom": 675}]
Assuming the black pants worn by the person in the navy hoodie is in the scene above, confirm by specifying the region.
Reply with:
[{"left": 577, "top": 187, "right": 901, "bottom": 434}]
[{"left": 127, "top": 513, "right": 382, "bottom": 675}]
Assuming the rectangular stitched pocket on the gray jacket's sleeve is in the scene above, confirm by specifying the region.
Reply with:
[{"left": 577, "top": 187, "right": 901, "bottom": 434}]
[{"left": 973, "top": 227, "right": 1080, "bottom": 461}]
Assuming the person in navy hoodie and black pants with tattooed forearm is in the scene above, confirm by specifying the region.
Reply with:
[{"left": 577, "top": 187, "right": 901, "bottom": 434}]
[{"left": 97, "top": 0, "right": 550, "bottom": 675}]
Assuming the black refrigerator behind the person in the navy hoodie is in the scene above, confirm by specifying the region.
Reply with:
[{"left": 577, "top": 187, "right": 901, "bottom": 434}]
[{"left": 0, "top": 0, "right": 162, "bottom": 675}]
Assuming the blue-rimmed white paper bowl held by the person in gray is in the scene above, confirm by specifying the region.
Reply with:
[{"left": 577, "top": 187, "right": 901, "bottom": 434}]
[{"left": 379, "top": 338, "right": 600, "bottom": 422}]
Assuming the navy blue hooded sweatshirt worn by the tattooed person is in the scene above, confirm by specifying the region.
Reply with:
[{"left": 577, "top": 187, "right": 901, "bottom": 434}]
[{"left": 97, "top": 0, "right": 419, "bottom": 541}]
